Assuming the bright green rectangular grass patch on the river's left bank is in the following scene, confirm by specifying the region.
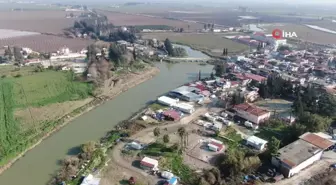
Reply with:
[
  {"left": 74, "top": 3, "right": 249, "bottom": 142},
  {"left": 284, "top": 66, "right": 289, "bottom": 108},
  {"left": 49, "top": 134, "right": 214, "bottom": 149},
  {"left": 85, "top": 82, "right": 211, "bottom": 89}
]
[{"left": 10, "top": 71, "right": 91, "bottom": 107}]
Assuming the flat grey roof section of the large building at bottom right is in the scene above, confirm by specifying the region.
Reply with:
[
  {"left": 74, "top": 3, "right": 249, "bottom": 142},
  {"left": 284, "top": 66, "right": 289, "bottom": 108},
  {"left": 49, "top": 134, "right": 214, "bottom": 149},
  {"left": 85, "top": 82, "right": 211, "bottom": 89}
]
[{"left": 278, "top": 139, "right": 322, "bottom": 167}]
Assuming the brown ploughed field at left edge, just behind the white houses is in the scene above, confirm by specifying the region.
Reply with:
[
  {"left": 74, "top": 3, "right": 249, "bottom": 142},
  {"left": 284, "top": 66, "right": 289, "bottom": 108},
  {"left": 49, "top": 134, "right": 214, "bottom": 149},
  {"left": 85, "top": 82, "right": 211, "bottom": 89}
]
[{"left": 0, "top": 35, "right": 94, "bottom": 52}]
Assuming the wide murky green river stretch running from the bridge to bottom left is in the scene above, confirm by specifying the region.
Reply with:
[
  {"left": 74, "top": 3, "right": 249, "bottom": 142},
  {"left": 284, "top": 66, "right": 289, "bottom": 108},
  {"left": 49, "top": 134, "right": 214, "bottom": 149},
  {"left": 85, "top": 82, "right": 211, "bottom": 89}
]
[{"left": 0, "top": 63, "right": 212, "bottom": 185}]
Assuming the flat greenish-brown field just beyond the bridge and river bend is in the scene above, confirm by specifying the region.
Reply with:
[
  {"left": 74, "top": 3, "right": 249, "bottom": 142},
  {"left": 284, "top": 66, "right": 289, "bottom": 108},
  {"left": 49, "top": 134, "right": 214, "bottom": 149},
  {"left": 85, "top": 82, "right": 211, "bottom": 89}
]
[{"left": 143, "top": 33, "right": 248, "bottom": 55}]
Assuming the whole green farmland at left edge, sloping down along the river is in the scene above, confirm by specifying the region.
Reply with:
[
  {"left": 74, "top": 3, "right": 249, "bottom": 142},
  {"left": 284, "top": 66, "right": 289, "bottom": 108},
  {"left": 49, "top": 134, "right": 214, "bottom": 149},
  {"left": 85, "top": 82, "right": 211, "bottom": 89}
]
[{"left": 0, "top": 71, "right": 92, "bottom": 166}]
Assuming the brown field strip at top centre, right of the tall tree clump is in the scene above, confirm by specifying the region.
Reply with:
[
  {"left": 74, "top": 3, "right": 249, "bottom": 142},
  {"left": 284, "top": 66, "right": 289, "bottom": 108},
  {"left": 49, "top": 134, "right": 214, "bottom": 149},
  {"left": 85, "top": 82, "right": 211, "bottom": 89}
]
[{"left": 96, "top": 10, "right": 203, "bottom": 30}]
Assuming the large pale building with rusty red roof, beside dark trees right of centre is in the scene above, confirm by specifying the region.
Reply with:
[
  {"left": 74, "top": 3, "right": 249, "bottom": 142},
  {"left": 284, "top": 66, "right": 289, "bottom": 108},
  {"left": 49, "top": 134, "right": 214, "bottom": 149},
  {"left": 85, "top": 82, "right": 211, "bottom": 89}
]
[{"left": 233, "top": 103, "right": 271, "bottom": 124}]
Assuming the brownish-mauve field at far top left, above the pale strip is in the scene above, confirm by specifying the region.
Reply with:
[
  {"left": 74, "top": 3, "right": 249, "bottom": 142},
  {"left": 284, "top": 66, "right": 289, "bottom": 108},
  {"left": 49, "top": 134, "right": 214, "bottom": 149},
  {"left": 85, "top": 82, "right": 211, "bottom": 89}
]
[{"left": 0, "top": 10, "right": 78, "bottom": 34}]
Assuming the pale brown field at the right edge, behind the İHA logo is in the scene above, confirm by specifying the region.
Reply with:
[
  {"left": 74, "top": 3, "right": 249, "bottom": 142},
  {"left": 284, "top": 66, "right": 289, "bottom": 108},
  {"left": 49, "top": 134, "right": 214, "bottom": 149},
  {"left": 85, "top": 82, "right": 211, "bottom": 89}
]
[{"left": 264, "top": 24, "right": 336, "bottom": 44}]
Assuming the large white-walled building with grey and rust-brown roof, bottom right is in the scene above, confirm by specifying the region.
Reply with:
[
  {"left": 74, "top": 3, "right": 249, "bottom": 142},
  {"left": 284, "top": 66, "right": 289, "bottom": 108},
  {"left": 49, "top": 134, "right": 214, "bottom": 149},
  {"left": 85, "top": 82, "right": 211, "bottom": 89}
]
[{"left": 272, "top": 132, "right": 334, "bottom": 177}]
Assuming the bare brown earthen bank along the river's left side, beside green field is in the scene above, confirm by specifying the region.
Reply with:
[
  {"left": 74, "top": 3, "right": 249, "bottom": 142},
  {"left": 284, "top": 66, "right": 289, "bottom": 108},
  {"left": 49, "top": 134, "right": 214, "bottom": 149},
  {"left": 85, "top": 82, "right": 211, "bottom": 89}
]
[{"left": 0, "top": 67, "right": 160, "bottom": 174}]
